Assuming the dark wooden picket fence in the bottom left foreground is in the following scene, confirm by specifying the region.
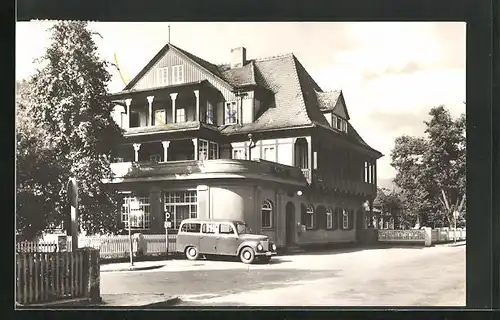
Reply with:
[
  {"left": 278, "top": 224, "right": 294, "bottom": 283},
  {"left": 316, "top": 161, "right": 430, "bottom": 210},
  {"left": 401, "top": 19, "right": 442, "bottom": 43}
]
[{"left": 16, "top": 249, "right": 99, "bottom": 305}]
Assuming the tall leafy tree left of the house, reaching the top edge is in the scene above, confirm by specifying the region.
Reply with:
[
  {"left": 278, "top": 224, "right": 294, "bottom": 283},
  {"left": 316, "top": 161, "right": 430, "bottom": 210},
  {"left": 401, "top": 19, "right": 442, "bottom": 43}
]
[{"left": 20, "top": 21, "right": 122, "bottom": 234}]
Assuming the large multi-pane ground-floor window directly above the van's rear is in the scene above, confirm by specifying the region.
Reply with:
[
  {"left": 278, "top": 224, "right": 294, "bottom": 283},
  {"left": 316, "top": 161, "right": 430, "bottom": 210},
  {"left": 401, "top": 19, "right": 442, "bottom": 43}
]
[{"left": 163, "top": 190, "right": 198, "bottom": 229}]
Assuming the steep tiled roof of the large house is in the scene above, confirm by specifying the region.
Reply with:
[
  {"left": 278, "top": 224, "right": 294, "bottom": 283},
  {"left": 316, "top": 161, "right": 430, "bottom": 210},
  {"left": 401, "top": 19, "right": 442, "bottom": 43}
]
[{"left": 122, "top": 44, "right": 378, "bottom": 157}]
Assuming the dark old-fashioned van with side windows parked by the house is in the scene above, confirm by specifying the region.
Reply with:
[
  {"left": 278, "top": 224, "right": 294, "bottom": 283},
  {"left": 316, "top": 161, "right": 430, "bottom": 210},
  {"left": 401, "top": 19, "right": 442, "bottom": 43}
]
[{"left": 176, "top": 219, "right": 276, "bottom": 264}]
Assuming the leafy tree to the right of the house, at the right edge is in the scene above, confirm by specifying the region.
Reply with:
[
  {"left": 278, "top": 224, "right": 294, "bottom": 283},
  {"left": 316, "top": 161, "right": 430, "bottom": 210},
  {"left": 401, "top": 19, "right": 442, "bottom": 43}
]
[{"left": 391, "top": 106, "right": 466, "bottom": 225}]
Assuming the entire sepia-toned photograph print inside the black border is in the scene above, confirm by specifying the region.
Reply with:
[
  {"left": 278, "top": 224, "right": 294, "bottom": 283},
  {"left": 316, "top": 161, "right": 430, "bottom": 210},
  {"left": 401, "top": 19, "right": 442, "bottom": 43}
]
[{"left": 15, "top": 20, "right": 473, "bottom": 309}]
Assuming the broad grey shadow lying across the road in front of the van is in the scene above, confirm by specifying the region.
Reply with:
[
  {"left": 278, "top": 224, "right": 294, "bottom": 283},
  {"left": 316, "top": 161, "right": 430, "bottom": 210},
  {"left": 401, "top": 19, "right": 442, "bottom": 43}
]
[{"left": 101, "top": 267, "right": 340, "bottom": 300}]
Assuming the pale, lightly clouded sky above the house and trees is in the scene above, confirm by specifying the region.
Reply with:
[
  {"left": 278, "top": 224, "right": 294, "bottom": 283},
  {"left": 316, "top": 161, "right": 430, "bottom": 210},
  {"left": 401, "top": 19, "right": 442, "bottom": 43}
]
[{"left": 16, "top": 21, "right": 466, "bottom": 186}]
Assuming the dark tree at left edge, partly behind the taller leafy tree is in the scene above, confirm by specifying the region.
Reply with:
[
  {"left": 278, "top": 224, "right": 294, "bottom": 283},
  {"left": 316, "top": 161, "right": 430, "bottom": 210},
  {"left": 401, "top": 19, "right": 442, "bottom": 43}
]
[{"left": 16, "top": 81, "right": 63, "bottom": 239}]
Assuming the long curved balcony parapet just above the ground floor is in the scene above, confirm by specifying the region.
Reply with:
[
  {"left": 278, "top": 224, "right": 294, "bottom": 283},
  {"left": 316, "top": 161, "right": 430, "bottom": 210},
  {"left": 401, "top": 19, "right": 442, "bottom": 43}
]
[{"left": 105, "top": 159, "right": 307, "bottom": 187}]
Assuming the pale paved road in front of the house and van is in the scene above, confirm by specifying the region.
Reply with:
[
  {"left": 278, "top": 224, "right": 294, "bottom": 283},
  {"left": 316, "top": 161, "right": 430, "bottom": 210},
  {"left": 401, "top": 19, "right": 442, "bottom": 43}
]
[{"left": 101, "top": 246, "right": 465, "bottom": 306}]
